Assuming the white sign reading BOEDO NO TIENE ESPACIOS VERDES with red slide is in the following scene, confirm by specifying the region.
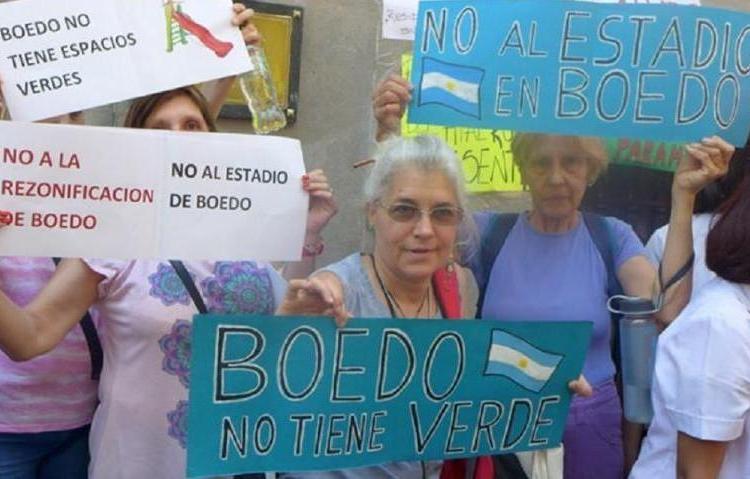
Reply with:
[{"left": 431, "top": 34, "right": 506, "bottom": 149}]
[{"left": 0, "top": 0, "right": 251, "bottom": 121}]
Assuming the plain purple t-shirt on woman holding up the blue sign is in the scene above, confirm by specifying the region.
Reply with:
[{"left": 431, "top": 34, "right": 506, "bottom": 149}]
[{"left": 476, "top": 213, "right": 645, "bottom": 386}]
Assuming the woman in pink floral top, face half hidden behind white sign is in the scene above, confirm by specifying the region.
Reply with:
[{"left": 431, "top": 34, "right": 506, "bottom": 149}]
[{"left": 0, "top": 88, "right": 336, "bottom": 479}]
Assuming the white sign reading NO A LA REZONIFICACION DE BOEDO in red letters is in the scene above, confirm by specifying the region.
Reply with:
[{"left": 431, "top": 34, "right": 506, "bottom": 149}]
[{"left": 0, "top": 121, "right": 308, "bottom": 261}]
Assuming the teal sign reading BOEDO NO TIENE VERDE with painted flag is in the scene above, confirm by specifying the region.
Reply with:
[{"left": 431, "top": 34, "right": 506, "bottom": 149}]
[{"left": 188, "top": 315, "right": 591, "bottom": 477}]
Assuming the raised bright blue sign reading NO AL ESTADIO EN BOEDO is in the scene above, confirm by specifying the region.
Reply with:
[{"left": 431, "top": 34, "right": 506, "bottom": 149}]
[{"left": 409, "top": 0, "right": 750, "bottom": 145}]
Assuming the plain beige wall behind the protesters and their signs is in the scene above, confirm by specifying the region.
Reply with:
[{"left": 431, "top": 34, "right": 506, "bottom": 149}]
[{"left": 0, "top": 0, "right": 750, "bottom": 262}]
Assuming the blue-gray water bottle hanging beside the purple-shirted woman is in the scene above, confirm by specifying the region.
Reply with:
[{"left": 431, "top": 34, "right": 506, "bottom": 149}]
[{"left": 609, "top": 296, "right": 658, "bottom": 424}]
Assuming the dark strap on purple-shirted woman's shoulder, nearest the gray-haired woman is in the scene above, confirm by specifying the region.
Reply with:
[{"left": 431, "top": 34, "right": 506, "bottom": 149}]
[{"left": 471, "top": 213, "right": 518, "bottom": 318}]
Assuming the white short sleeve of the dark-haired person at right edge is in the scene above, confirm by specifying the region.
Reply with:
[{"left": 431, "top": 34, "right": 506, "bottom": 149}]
[{"left": 654, "top": 308, "right": 750, "bottom": 441}]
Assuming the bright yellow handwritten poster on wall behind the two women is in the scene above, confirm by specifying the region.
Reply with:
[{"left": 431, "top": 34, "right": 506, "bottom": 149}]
[{"left": 401, "top": 54, "right": 523, "bottom": 193}]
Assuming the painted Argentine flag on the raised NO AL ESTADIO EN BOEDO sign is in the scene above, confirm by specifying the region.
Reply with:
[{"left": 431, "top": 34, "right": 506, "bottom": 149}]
[{"left": 419, "top": 57, "right": 484, "bottom": 119}]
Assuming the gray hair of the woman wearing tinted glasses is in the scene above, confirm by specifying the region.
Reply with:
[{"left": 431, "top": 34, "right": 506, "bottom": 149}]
[{"left": 364, "top": 135, "right": 477, "bottom": 258}]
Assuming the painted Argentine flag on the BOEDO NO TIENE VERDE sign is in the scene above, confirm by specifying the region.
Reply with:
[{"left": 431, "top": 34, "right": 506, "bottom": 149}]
[{"left": 484, "top": 329, "right": 563, "bottom": 393}]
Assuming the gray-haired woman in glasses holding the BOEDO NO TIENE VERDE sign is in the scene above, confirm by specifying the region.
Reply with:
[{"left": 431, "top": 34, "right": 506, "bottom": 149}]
[{"left": 278, "top": 136, "right": 588, "bottom": 479}]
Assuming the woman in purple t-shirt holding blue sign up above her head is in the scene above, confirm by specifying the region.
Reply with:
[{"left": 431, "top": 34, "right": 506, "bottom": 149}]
[{"left": 373, "top": 75, "right": 734, "bottom": 479}]
